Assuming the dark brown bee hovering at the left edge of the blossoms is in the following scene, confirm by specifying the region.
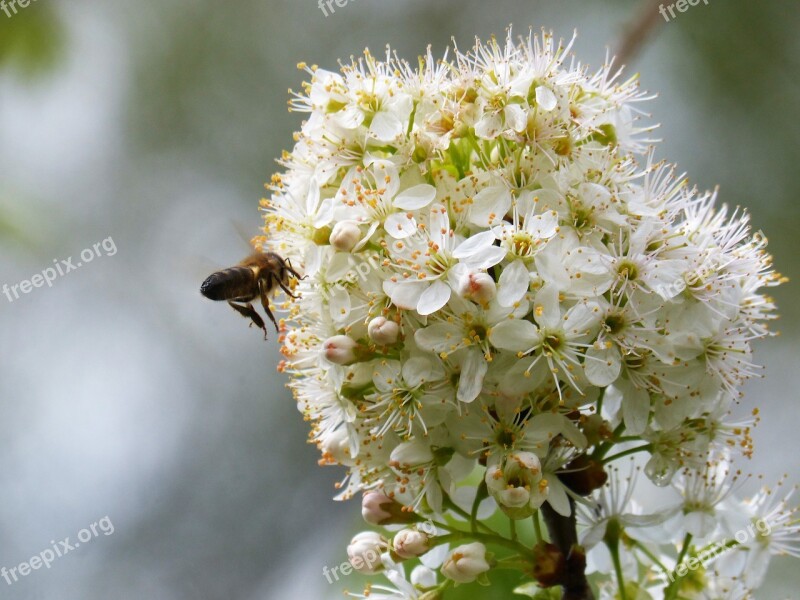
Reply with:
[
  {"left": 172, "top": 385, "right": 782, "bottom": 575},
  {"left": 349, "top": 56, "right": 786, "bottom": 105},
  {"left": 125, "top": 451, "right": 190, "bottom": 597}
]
[{"left": 200, "top": 252, "right": 302, "bottom": 339}]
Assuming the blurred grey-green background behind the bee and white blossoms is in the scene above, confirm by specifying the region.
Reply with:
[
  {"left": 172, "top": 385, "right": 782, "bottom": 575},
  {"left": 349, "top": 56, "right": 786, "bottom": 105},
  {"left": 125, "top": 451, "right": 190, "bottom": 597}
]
[{"left": 0, "top": 0, "right": 800, "bottom": 600}]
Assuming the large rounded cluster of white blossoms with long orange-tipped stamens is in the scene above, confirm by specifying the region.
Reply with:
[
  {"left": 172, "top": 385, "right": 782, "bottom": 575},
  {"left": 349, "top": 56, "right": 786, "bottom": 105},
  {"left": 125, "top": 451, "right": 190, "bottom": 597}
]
[{"left": 260, "top": 33, "right": 797, "bottom": 598}]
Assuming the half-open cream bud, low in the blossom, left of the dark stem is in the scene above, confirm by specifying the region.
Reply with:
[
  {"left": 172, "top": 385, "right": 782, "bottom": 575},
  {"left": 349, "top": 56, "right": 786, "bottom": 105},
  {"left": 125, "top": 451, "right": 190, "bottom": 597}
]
[{"left": 485, "top": 452, "right": 547, "bottom": 519}]
